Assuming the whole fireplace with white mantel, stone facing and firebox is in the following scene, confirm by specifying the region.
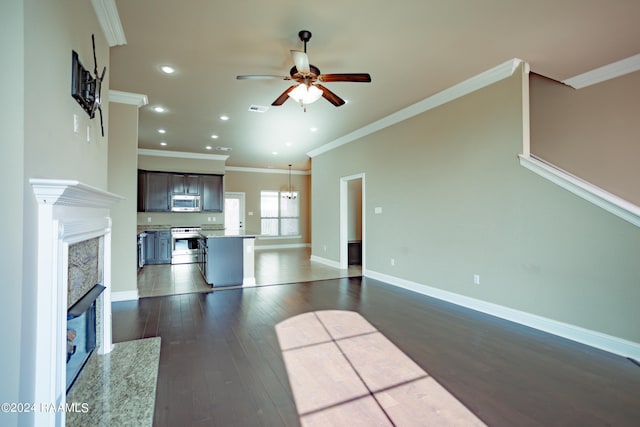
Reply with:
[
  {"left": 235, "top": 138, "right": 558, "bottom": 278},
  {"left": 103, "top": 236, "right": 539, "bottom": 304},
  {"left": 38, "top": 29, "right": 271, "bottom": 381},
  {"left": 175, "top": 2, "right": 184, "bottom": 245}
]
[{"left": 30, "top": 179, "right": 122, "bottom": 425}]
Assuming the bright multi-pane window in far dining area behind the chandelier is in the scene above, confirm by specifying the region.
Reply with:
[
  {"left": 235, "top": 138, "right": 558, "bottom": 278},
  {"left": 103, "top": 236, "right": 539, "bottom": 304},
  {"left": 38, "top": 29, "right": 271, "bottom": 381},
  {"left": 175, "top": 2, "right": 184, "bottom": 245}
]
[{"left": 260, "top": 191, "right": 300, "bottom": 236}]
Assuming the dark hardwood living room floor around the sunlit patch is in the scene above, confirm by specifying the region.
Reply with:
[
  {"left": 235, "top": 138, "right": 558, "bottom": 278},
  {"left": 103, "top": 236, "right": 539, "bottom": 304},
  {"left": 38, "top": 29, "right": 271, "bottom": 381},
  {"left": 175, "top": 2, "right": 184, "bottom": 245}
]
[{"left": 113, "top": 277, "right": 640, "bottom": 426}]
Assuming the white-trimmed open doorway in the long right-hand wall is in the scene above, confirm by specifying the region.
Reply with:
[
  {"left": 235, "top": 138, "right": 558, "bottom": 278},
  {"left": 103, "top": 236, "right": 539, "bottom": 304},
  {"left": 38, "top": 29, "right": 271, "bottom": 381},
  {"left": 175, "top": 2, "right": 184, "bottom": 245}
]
[{"left": 340, "top": 173, "right": 366, "bottom": 272}]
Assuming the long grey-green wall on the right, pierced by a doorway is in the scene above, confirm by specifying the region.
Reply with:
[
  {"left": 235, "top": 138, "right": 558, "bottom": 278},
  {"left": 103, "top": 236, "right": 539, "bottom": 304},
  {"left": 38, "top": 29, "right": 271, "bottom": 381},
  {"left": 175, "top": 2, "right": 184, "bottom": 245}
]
[{"left": 312, "top": 72, "right": 640, "bottom": 342}]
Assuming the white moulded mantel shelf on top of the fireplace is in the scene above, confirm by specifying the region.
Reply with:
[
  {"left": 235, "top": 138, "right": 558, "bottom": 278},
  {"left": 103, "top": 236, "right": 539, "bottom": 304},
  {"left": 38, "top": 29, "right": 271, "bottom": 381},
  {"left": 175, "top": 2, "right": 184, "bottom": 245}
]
[{"left": 29, "top": 178, "right": 124, "bottom": 208}]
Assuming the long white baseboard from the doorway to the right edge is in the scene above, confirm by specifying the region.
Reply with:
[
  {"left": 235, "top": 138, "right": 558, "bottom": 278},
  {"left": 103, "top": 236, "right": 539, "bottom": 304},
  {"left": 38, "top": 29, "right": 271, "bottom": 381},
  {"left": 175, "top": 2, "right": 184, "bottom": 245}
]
[{"left": 363, "top": 270, "right": 640, "bottom": 360}]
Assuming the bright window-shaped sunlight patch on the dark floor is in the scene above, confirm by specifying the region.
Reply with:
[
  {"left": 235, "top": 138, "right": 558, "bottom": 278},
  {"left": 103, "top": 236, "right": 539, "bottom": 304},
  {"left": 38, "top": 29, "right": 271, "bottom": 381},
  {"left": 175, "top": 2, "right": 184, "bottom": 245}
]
[{"left": 276, "top": 310, "right": 485, "bottom": 426}]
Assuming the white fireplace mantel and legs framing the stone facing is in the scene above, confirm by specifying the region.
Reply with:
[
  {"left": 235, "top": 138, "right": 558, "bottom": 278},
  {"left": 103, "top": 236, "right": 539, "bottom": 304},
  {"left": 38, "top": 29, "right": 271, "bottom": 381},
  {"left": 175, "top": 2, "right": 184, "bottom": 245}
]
[{"left": 30, "top": 179, "right": 122, "bottom": 426}]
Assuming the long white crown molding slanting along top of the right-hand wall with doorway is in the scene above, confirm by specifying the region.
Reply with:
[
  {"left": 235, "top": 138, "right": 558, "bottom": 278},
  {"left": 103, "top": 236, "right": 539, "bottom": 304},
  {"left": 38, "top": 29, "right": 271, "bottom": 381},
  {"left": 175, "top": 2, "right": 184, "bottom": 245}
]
[{"left": 307, "top": 58, "right": 522, "bottom": 157}]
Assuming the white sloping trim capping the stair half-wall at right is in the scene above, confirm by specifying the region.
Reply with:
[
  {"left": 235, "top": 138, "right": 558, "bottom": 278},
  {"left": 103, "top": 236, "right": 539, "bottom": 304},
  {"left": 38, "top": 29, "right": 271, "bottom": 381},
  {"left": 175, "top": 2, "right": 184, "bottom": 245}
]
[{"left": 518, "top": 154, "right": 640, "bottom": 227}]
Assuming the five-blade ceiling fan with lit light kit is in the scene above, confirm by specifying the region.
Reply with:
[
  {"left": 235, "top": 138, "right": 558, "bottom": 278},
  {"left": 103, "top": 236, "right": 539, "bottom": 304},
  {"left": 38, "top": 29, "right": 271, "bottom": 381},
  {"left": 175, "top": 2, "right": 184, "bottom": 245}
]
[{"left": 236, "top": 30, "right": 371, "bottom": 111}]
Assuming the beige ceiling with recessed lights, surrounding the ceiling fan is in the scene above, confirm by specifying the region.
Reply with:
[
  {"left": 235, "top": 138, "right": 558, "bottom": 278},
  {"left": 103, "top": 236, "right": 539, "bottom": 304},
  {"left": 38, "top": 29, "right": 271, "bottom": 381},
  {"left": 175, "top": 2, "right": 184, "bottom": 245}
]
[{"left": 108, "top": 0, "right": 640, "bottom": 170}]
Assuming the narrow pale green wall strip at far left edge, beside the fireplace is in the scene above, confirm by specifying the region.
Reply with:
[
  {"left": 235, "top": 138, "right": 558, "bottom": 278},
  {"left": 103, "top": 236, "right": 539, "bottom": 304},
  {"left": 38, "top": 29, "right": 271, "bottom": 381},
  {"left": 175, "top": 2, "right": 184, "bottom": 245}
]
[{"left": 0, "top": 0, "right": 25, "bottom": 426}]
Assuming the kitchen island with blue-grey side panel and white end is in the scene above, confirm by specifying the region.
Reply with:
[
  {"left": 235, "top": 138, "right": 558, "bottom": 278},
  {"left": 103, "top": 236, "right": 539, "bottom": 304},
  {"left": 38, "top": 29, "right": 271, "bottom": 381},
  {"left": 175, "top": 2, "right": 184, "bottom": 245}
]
[{"left": 197, "top": 228, "right": 256, "bottom": 288}]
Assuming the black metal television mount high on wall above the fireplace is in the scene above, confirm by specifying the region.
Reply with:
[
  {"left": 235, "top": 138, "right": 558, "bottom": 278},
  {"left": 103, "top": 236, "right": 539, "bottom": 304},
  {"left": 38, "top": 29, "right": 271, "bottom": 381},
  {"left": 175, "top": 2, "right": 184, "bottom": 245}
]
[{"left": 71, "top": 34, "right": 107, "bottom": 137}]
